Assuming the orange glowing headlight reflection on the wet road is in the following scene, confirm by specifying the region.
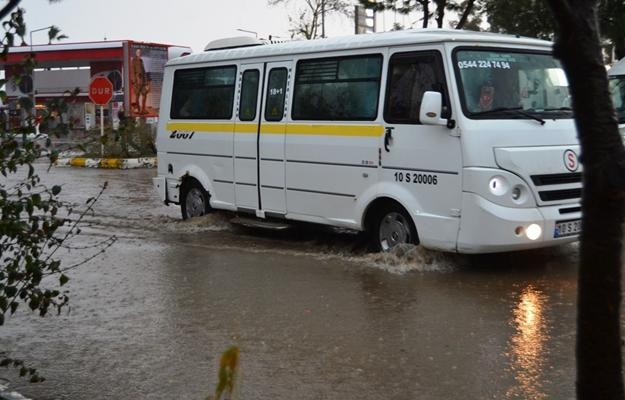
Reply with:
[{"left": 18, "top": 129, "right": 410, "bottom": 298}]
[{"left": 507, "top": 285, "right": 550, "bottom": 400}]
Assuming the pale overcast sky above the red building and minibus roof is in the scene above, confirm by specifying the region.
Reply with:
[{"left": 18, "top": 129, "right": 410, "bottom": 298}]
[{"left": 20, "top": 0, "right": 354, "bottom": 51}]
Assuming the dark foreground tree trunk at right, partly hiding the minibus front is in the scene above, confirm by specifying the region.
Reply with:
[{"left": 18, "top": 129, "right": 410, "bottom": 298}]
[{"left": 548, "top": 0, "right": 625, "bottom": 400}]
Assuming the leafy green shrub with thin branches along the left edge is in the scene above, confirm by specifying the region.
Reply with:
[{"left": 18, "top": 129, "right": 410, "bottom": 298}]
[{"left": 0, "top": 0, "right": 116, "bottom": 382}]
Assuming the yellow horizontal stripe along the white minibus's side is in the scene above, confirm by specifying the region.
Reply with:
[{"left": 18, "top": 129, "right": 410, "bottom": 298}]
[{"left": 167, "top": 122, "right": 384, "bottom": 137}]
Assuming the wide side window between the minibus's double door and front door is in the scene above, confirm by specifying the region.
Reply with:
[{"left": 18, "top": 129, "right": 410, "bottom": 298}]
[{"left": 293, "top": 54, "right": 382, "bottom": 121}]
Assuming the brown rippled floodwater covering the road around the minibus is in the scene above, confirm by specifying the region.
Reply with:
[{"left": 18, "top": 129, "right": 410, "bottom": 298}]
[{"left": 0, "top": 163, "right": 578, "bottom": 400}]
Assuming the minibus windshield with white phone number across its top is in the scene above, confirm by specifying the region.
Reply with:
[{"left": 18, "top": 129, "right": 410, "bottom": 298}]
[{"left": 454, "top": 48, "right": 572, "bottom": 119}]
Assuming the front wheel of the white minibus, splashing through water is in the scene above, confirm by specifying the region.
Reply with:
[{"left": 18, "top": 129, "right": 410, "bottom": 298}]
[{"left": 371, "top": 204, "right": 419, "bottom": 252}]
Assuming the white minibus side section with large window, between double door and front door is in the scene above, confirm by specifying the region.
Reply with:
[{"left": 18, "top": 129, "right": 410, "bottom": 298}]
[{"left": 285, "top": 49, "right": 385, "bottom": 229}]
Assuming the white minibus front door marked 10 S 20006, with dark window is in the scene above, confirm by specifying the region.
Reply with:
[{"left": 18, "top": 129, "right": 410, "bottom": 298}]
[{"left": 380, "top": 46, "right": 462, "bottom": 250}]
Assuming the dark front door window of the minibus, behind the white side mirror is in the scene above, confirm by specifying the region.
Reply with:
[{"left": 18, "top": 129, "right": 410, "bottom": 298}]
[{"left": 384, "top": 52, "right": 451, "bottom": 124}]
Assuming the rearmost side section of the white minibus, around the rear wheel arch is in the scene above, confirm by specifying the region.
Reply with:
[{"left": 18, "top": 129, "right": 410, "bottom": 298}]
[{"left": 157, "top": 63, "right": 236, "bottom": 208}]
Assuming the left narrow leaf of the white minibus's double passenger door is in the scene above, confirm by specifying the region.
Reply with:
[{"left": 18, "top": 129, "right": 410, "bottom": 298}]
[{"left": 234, "top": 64, "right": 263, "bottom": 213}]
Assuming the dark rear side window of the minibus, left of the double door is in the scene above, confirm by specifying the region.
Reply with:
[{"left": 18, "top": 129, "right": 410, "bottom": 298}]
[{"left": 170, "top": 66, "right": 237, "bottom": 119}]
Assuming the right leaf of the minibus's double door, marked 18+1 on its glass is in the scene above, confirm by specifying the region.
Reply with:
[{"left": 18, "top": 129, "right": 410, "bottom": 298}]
[{"left": 258, "top": 62, "right": 291, "bottom": 217}]
